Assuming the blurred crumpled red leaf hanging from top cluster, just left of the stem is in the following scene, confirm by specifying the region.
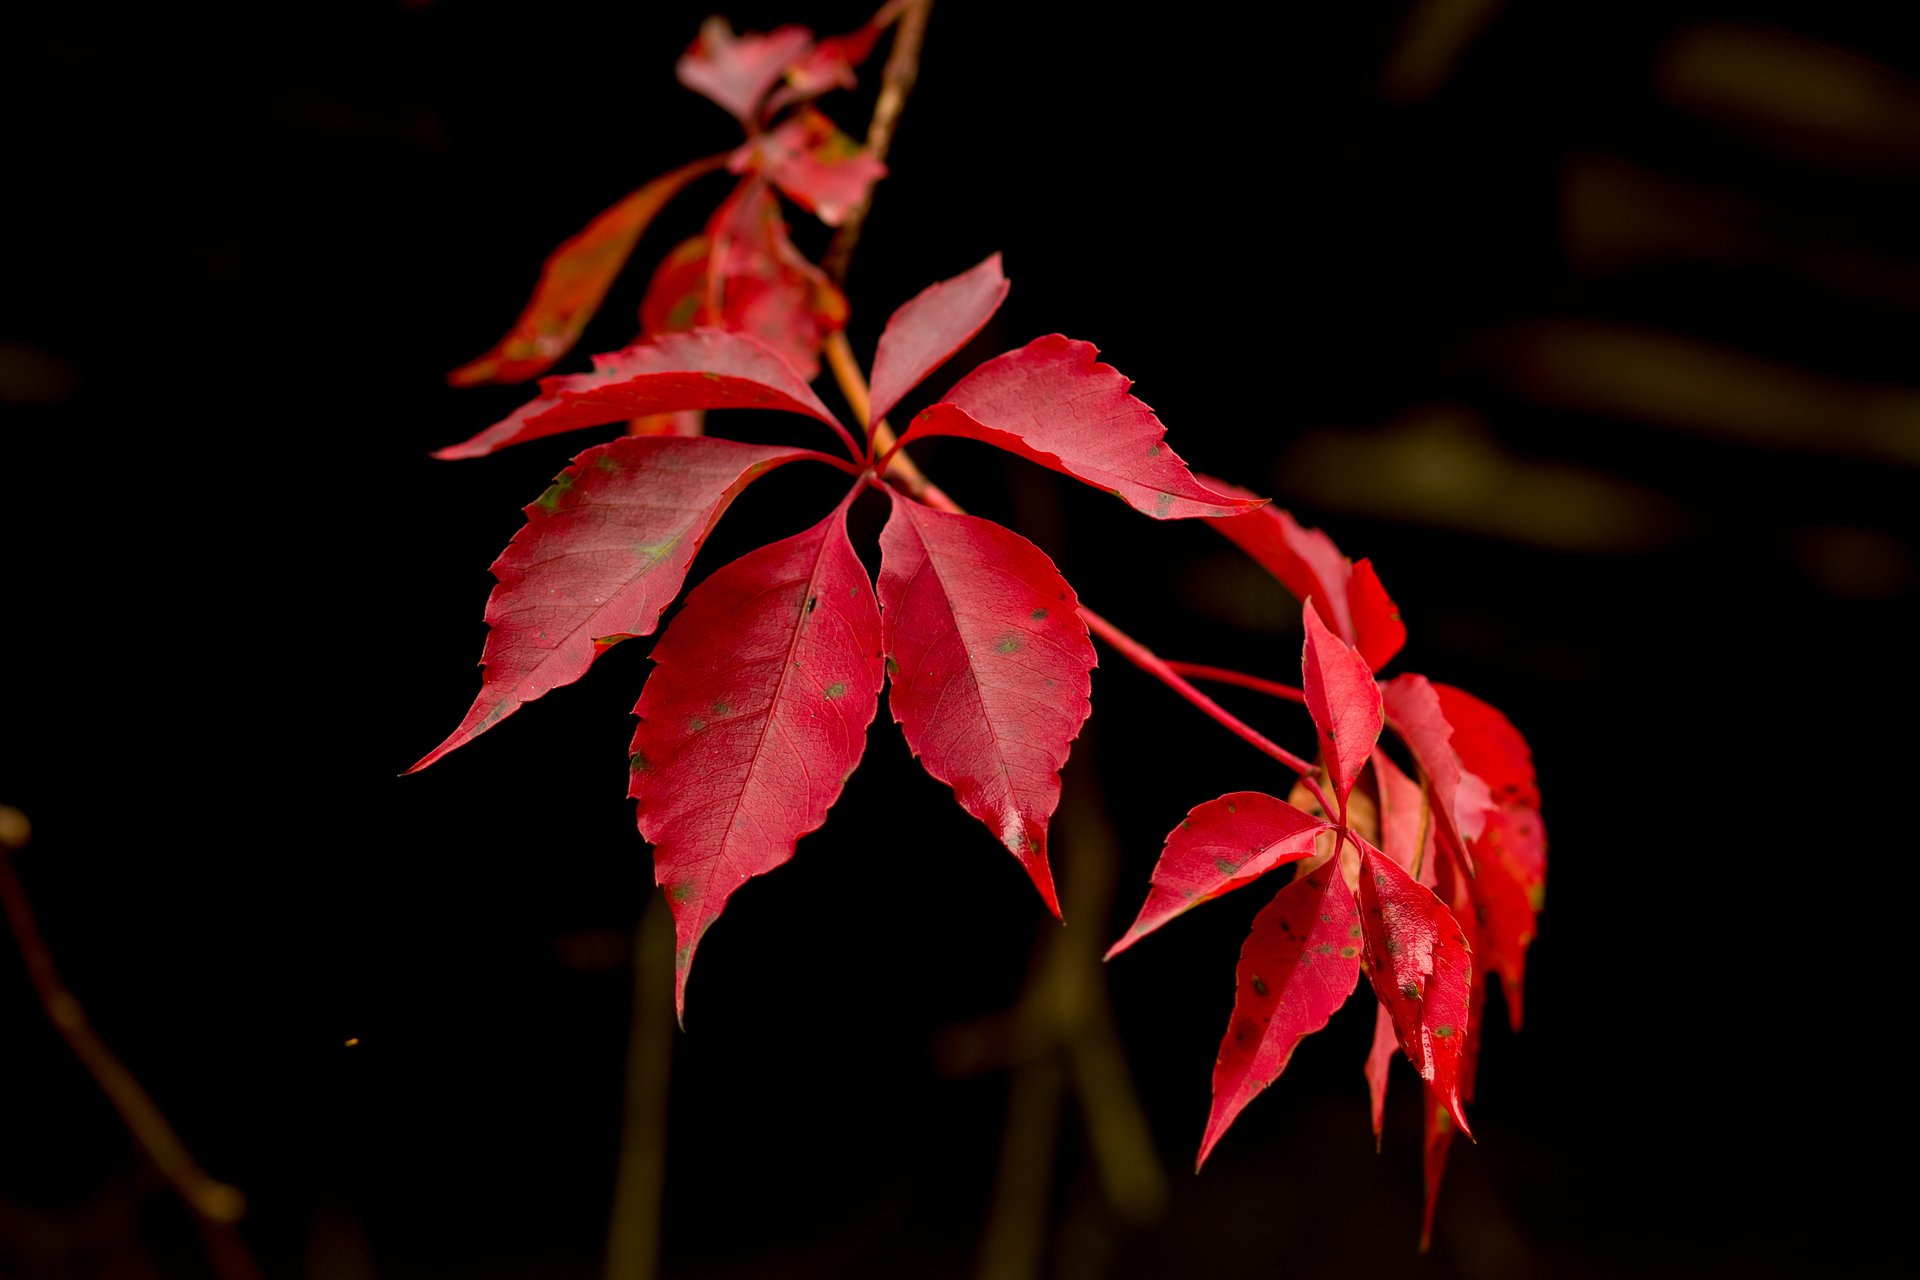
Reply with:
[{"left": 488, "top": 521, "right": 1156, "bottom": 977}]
[{"left": 707, "top": 178, "right": 847, "bottom": 382}]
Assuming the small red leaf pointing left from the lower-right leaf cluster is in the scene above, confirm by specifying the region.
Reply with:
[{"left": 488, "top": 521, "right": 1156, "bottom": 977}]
[{"left": 1106, "top": 791, "right": 1332, "bottom": 960}]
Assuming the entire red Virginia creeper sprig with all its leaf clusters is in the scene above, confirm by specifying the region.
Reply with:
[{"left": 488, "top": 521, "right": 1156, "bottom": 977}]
[{"left": 413, "top": 4, "right": 1546, "bottom": 1230}]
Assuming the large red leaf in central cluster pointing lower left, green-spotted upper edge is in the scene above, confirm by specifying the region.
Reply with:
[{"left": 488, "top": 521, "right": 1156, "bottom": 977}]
[{"left": 407, "top": 436, "right": 818, "bottom": 773}]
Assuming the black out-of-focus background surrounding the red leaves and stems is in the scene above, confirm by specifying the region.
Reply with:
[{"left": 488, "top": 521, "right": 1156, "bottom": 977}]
[{"left": 0, "top": 0, "right": 1920, "bottom": 1280}]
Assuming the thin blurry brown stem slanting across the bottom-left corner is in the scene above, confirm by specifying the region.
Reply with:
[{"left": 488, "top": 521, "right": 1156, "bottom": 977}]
[{"left": 0, "top": 806, "right": 259, "bottom": 1280}]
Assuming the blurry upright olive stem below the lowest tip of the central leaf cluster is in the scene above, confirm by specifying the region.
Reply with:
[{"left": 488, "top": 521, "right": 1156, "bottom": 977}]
[{"left": 605, "top": 892, "right": 674, "bottom": 1280}]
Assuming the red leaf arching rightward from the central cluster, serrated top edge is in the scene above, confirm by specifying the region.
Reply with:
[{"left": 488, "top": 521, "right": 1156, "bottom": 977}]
[{"left": 900, "top": 334, "right": 1261, "bottom": 520}]
